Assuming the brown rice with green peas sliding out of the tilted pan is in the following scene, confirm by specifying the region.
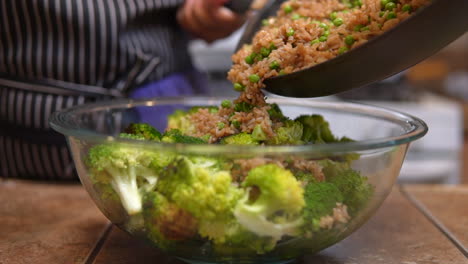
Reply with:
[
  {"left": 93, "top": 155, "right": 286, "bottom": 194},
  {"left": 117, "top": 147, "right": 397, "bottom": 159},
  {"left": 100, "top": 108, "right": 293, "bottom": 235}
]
[{"left": 228, "top": 0, "right": 431, "bottom": 105}]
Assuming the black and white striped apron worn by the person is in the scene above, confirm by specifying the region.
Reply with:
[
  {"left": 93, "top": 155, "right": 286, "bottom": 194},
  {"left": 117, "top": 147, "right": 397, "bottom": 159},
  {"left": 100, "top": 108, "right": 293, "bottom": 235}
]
[{"left": 0, "top": 0, "right": 192, "bottom": 180}]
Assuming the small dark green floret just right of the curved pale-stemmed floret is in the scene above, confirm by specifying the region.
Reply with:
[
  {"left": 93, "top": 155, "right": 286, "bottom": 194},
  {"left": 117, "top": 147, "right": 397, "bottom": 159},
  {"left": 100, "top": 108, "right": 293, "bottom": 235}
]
[{"left": 303, "top": 182, "right": 344, "bottom": 231}]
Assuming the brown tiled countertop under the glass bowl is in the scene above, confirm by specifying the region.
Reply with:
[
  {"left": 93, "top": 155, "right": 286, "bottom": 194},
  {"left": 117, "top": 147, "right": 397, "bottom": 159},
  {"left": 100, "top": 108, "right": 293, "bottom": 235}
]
[{"left": 0, "top": 180, "right": 468, "bottom": 264}]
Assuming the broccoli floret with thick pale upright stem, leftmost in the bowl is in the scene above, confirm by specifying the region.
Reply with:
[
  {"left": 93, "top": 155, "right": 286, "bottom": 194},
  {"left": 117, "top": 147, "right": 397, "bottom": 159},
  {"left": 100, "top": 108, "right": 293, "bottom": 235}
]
[{"left": 86, "top": 143, "right": 171, "bottom": 215}]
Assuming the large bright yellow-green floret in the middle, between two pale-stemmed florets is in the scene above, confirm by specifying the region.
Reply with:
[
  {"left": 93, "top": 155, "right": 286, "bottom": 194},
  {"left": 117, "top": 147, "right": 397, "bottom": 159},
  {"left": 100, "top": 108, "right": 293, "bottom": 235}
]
[{"left": 156, "top": 157, "right": 243, "bottom": 243}]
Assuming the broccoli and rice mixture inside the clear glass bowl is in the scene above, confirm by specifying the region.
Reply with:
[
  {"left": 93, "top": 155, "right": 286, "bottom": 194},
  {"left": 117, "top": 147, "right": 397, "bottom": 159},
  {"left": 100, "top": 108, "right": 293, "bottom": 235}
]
[{"left": 86, "top": 101, "right": 373, "bottom": 255}]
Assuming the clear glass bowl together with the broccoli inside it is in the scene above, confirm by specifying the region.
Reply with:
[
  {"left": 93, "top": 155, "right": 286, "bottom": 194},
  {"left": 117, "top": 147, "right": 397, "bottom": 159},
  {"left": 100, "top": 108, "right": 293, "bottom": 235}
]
[{"left": 51, "top": 97, "right": 427, "bottom": 263}]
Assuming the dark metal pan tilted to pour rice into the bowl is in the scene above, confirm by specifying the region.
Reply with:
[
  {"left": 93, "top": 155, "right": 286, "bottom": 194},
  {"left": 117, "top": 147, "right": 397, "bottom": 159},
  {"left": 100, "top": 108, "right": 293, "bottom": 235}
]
[{"left": 237, "top": 0, "right": 468, "bottom": 97}]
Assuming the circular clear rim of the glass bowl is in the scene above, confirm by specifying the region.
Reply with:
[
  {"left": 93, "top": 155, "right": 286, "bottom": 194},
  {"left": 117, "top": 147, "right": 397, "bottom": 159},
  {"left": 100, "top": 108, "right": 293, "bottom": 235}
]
[{"left": 49, "top": 96, "right": 428, "bottom": 155}]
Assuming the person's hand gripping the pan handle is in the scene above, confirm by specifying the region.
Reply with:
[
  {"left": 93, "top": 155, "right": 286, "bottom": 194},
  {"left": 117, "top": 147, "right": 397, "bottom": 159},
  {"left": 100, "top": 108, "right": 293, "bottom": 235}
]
[{"left": 177, "top": 0, "right": 245, "bottom": 42}]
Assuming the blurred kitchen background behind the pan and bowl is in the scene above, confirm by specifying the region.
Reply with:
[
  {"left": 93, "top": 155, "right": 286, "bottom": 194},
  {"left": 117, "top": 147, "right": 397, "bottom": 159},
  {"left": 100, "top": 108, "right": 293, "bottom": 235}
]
[{"left": 190, "top": 29, "right": 468, "bottom": 184}]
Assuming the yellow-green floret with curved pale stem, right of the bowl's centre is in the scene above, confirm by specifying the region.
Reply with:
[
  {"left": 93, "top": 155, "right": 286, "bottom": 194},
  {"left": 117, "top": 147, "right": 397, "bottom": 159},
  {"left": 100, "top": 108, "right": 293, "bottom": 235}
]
[{"left": 234, "top": 164, "right": 305, "bottom": 240}]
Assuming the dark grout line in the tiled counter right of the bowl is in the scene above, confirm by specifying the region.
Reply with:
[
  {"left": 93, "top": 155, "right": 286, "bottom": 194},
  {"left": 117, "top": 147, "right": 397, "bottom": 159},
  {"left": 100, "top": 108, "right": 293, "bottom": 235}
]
[{"left": 399, "top": 185, "right": 468, "bottom": 258}]
